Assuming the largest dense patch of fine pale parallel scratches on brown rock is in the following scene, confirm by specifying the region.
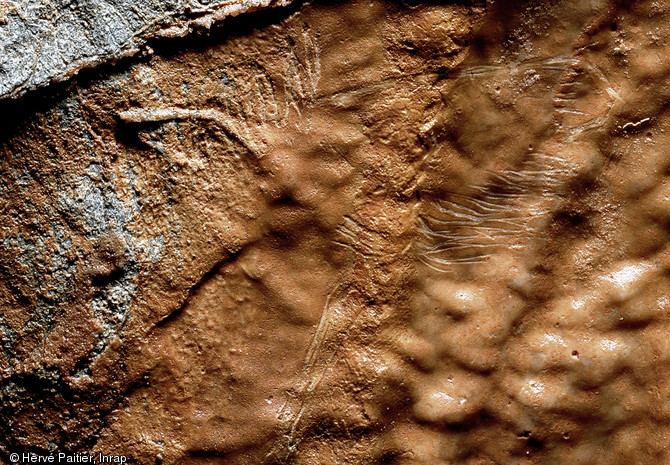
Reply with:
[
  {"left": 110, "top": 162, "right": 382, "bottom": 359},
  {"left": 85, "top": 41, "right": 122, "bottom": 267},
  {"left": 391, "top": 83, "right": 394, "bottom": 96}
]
[{"left": 417, "top": 153, "right": 571, "bottom": 272}]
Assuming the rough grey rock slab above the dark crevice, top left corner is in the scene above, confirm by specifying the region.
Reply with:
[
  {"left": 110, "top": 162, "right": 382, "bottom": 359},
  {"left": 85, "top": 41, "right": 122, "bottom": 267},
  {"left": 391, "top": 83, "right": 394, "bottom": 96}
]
[{"left": 0, "top": 0, "right": 290, "bottom": 99}]
